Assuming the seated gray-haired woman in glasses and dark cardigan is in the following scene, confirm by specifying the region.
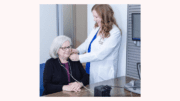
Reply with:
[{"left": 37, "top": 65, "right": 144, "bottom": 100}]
[{"left": 43, "top": 35, "right": 89, "bottom": 95}]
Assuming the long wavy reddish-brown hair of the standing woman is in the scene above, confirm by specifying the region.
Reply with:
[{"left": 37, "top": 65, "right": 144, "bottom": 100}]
[{"left": 91, "top": 4, "right": 121, "bottom": 38}]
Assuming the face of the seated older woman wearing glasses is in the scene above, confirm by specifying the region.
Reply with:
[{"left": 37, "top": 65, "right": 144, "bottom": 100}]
[{"left": 58, "top": 41, "right": 71, "bottom": 59}]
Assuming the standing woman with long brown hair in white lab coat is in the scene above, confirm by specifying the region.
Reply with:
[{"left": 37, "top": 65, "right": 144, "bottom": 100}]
[{"left": 70, "top": 4, "right": 121, "bottom": 84}]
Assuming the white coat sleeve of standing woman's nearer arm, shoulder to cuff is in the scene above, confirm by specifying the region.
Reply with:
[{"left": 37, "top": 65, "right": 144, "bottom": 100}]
[{"left": 79, "top": 31, "right": 121, "bottom": 63}]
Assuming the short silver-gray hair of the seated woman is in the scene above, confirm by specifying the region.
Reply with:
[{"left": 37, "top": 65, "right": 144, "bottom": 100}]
[{"left": 49, "top": 35, "right": 72, "bottom": 59}]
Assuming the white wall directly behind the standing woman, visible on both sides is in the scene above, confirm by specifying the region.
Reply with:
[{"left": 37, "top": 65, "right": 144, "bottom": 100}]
[{"left": 87, "top": 4, "right": 127, "bottom": 77}]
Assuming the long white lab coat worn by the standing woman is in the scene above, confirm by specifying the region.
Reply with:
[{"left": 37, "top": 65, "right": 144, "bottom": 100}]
[{"left": 77, "top": 25, "right": 121, "bottom": 84}]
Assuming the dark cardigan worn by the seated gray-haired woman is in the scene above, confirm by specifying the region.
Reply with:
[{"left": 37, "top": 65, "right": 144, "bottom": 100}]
[{"left": 43, "top": 58, "right": 89, "bottom": 95}]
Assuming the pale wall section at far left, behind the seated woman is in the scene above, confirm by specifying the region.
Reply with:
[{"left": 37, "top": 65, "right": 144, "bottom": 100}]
[{"left": 40, "top": 4, "right": 57, "bottom": 64}]
